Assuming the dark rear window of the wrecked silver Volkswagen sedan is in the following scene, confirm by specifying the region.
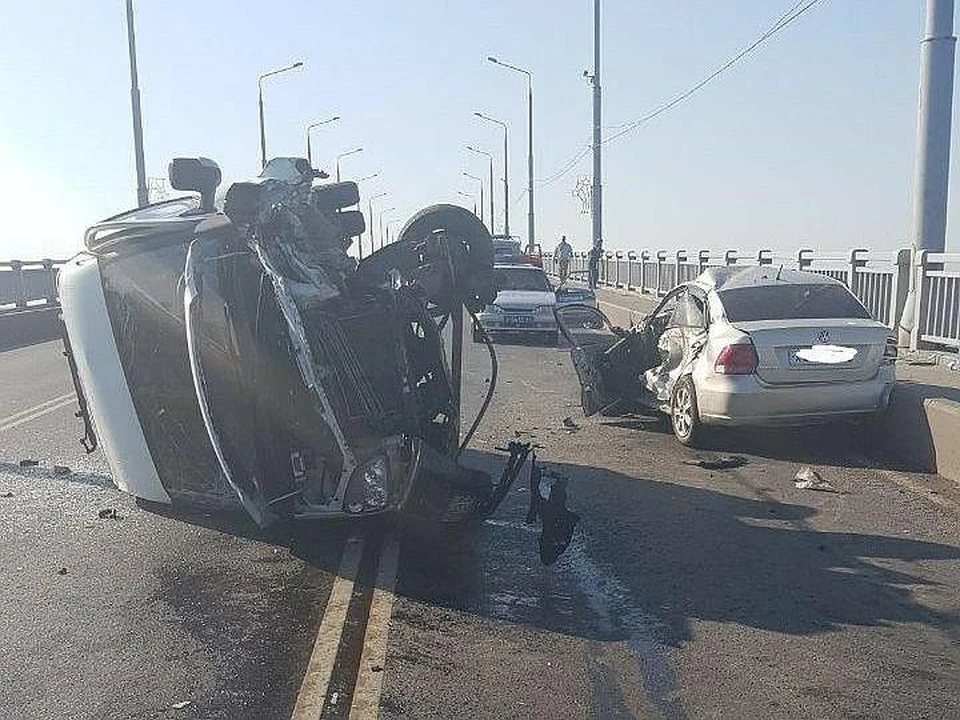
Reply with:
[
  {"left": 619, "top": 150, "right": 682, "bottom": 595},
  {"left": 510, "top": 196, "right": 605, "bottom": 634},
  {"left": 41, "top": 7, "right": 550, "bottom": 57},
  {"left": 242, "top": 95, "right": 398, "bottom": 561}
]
[{"left": 718, "top": 284, "right": 870, "bottom": 322}]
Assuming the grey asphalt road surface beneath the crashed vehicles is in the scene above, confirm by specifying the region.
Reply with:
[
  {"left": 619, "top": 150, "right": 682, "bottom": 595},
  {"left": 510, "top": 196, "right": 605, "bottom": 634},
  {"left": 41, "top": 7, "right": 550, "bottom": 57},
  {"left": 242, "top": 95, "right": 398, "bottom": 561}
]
[{"left": 0, "top": 293, "right": 960, "bottom": 719}]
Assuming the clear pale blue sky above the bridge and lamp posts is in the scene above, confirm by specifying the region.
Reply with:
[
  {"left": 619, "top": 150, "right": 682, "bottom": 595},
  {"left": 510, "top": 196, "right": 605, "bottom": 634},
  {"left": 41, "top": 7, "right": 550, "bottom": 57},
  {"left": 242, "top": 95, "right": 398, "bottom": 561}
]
[{"left": 0, "top": 0, "right": 948, "bottom": 258}]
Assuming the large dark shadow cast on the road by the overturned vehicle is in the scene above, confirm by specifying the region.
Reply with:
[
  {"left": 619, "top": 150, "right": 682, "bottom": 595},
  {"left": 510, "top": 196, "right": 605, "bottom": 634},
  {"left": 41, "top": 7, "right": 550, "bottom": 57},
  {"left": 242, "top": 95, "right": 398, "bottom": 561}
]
[{"left": 133, "top": 452, "right": 960, "bottom": 645}]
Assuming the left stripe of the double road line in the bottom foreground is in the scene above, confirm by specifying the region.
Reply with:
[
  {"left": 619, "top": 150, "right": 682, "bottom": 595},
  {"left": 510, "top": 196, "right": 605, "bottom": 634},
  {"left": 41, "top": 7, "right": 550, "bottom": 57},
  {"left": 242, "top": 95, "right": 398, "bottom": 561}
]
[{"left": 291, "top": 538, "right": 363, "bottom": 720}]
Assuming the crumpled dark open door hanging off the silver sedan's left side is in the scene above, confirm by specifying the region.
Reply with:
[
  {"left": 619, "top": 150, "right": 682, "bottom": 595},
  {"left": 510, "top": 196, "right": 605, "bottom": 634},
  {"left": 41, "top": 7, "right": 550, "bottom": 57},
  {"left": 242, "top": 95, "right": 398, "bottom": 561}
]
[{"left": 555, "top": 305, "right": 656, "bottom": 417}]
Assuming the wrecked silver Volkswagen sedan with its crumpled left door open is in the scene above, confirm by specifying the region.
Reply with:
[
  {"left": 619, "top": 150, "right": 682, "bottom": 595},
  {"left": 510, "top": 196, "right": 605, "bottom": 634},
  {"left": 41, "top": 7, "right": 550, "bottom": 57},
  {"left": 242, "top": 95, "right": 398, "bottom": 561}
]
[{"left": 557, "top": 266, "right": 896, "bottom": 445}]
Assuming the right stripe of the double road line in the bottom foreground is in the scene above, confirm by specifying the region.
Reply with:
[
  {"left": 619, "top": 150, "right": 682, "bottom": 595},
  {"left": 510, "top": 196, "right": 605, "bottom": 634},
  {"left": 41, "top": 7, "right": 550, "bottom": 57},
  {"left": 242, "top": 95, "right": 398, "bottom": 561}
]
[{"left": 350, "top": 534, "right": 400, "bottom": 720}]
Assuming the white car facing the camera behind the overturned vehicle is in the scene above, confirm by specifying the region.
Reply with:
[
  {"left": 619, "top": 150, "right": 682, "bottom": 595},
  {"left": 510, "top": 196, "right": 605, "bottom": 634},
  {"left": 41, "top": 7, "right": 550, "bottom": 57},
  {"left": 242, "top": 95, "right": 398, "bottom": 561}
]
[{"left": 473, "top": 263, "right": 557, "bottom": 344}]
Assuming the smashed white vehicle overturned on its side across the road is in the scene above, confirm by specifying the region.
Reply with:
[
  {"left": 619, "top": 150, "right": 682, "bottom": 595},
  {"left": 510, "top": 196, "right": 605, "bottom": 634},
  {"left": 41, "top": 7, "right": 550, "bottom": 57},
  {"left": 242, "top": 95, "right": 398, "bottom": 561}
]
[{"left": 59, "top": 158, "right": 569, "bottom": 556}]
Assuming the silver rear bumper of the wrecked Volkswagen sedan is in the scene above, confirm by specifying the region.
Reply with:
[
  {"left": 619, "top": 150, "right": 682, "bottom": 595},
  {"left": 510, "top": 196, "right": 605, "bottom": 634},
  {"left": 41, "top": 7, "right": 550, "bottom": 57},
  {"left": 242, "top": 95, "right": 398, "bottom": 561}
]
[{"left": 696, "top": 366, "right": 896, "bottom": 425}]
